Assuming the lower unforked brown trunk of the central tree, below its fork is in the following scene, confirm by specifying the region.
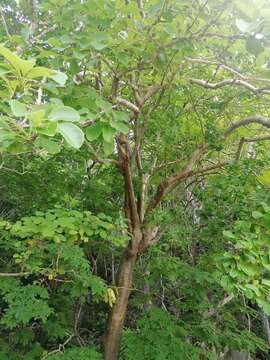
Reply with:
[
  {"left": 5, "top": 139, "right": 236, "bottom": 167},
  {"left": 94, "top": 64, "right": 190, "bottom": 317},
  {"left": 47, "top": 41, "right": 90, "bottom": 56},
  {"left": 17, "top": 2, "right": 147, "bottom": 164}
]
[{"left": 104, "top": 247, "right": 137, "bottom": 360}]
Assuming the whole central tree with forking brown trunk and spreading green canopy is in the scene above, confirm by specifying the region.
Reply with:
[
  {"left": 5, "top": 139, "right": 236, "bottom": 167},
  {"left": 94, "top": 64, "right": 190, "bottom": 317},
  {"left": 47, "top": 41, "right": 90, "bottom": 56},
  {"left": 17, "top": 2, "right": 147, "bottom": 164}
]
[{"left": 1, "top": 0, "right": 270, "bottom": 360}]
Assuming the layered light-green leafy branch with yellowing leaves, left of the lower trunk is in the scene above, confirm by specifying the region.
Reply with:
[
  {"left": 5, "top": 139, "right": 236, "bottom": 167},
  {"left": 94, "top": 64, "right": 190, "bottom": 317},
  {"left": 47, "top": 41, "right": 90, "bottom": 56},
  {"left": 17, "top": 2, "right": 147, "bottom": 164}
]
[{"left": 1, "top": 207, "right": 122, "bottom": 299}]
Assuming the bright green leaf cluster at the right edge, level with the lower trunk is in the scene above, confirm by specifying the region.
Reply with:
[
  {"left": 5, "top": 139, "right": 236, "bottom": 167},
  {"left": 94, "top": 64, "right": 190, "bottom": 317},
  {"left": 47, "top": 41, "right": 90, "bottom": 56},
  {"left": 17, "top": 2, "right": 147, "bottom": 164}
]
[{"left": 220, "top": 203, "right": 270, "bottom": 314}]
